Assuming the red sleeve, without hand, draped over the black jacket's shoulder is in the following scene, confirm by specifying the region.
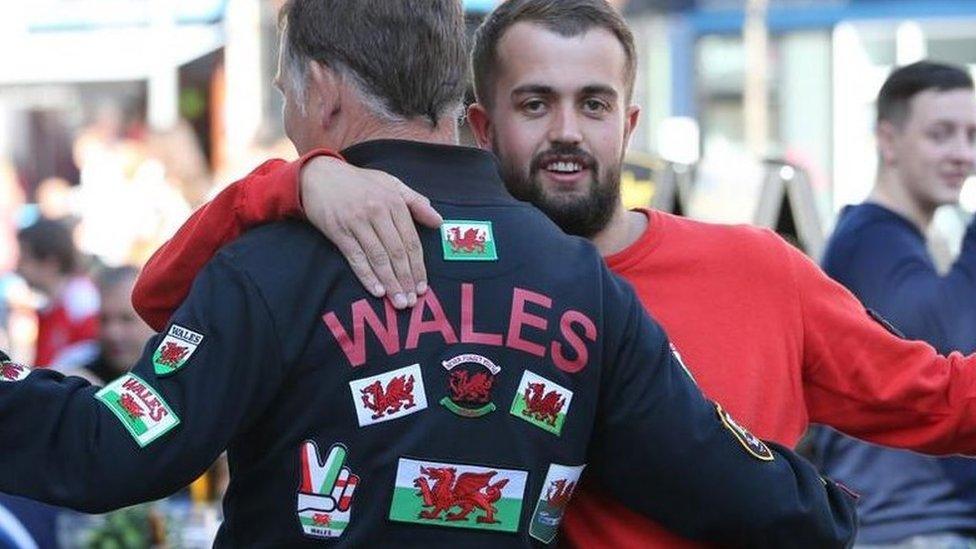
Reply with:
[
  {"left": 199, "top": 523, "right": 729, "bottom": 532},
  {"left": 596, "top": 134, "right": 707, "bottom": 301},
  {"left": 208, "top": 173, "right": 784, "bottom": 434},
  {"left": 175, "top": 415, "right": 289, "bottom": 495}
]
[{"left": 132, "top": 149, "right": 341, "bottom": 331}]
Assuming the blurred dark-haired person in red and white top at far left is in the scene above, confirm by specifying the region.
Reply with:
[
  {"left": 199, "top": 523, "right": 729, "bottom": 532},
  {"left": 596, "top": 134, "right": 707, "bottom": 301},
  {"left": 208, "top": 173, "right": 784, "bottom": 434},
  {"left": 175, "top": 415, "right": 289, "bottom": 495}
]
[{"left": 17, "top": 218, "right": 99, "bottom": 372}]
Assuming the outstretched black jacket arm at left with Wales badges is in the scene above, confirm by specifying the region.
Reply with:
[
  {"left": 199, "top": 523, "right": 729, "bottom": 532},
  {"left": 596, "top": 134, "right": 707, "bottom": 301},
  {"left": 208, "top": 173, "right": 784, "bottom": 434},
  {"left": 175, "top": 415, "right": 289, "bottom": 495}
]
[{"left": 0, "top": 254, "right": 283, "bottom": 512}]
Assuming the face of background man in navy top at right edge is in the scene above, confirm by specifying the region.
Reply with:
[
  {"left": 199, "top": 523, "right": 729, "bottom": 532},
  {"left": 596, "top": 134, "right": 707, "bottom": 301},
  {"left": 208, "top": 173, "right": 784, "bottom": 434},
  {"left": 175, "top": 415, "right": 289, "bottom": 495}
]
[{"left": 878, "top": 89, "right": 976, "bottom": 210}]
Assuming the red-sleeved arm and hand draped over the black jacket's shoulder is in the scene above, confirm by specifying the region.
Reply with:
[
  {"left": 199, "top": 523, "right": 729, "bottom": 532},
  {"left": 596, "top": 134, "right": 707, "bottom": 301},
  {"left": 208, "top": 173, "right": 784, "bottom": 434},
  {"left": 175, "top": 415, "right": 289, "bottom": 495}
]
[{"left": 132, "top": 149, "right": 441, "bottom": 330}]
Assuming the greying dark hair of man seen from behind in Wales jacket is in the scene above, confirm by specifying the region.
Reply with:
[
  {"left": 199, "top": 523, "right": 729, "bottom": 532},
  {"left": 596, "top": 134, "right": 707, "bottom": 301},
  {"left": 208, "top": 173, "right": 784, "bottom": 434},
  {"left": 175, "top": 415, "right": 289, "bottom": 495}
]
[{"left": 279, "top": 0, "right": 467, "bottom": 125}]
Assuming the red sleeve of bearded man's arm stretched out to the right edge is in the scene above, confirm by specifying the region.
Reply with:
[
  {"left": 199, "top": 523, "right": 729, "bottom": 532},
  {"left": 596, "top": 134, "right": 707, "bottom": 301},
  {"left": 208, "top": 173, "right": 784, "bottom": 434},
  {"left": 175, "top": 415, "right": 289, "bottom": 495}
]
[{"left": 790, "top": 244, "right": 976, "bottom": 455}]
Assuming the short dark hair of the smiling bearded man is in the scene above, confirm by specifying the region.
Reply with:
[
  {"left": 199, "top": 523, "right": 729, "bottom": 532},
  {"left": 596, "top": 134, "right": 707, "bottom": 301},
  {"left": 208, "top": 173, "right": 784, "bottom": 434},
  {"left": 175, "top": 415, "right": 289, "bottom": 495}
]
[{"left": 471, "top": 0, "right": 637, "bottom": 107}]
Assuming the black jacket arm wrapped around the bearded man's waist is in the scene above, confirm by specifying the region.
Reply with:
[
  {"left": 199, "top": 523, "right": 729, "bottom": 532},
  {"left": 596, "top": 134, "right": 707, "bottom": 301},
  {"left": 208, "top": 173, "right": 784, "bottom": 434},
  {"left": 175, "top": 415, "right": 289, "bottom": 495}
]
[{"left": 587, "top": 276, "right": 856, "bottom": 548}]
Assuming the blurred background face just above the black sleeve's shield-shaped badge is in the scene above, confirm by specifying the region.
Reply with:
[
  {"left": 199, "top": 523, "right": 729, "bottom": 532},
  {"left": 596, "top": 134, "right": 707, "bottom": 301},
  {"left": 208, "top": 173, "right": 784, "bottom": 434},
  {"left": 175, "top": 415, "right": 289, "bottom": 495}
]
[{"left": 99, "top": 278, "right": 154, "bottom": 372}]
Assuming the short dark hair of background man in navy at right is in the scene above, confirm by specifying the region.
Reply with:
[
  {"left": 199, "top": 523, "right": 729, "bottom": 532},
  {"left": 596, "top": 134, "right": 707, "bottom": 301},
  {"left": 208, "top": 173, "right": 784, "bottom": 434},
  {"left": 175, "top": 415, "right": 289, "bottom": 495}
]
[{"left": 878, "top": 61, "right": 974, "bottom": 126}]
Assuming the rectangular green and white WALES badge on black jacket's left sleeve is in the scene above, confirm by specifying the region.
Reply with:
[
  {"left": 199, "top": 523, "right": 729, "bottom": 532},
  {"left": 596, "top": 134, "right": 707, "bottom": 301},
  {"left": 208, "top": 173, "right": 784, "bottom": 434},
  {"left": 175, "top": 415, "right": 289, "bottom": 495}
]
[{"left": 95, "top": 374, "right": 180, "bottom": 448}]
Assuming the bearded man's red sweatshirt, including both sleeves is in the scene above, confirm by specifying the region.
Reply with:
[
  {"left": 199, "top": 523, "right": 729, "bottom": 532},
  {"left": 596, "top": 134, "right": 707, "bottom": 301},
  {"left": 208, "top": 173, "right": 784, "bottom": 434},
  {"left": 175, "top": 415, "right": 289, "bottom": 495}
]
[{"left": 133, "top": 156, "right": 976, "bottom": 547}]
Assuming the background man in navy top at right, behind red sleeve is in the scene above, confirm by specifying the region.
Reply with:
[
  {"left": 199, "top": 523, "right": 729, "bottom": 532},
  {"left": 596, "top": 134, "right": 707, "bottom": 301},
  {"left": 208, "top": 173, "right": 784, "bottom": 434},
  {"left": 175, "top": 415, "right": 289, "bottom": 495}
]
[{"left": 817, "top": 61, "right": 976, "bottom": 549}]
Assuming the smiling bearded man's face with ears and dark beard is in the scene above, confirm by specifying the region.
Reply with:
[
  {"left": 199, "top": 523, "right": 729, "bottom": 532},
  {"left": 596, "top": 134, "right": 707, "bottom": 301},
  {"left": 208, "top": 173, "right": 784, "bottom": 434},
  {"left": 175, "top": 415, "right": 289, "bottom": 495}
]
[{"left": 469, "top": 22, "right": 639, "bottom": 237}]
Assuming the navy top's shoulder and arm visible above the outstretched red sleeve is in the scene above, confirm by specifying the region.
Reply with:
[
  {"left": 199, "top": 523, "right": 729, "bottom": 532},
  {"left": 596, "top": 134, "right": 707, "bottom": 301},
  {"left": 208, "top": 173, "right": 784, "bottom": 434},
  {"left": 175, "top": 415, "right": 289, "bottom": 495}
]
[{"left": 828, "top": 218, "right": 976, "bottom": 353}]
